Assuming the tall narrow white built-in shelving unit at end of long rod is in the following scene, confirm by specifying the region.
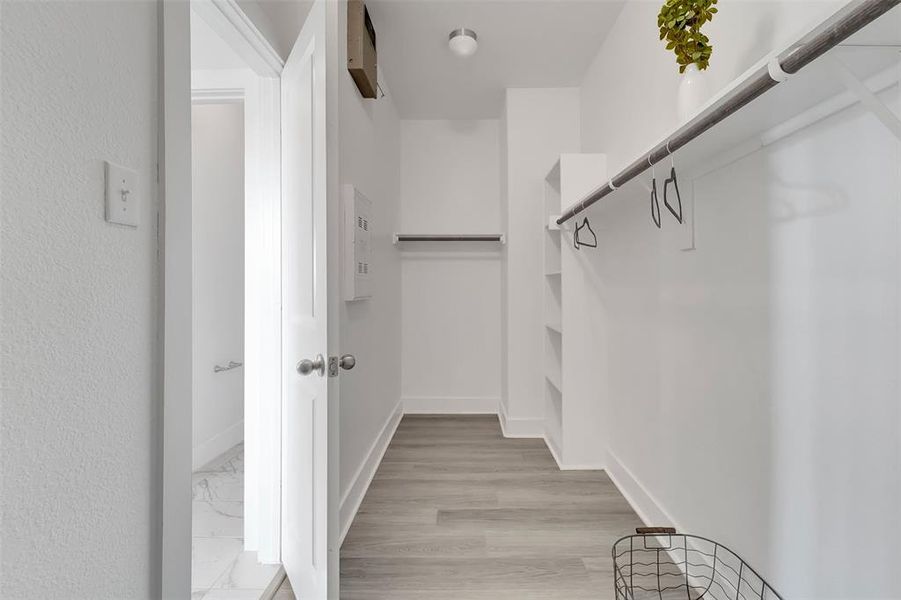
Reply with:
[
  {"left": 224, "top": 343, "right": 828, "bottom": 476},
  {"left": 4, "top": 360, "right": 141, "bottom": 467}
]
[{"left": 543, "top": 154, "right": 607, "bottom": 469}]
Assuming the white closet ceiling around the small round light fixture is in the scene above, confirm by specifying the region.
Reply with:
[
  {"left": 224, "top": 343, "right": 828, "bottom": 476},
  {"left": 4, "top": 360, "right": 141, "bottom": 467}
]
[{"left": 367, "top": 0, "right": 623, "bottom": 119}]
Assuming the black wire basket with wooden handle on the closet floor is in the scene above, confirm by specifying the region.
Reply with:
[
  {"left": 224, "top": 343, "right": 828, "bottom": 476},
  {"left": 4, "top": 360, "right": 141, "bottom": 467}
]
[{"left": 613, "top": 527, "right": 782, "bottom": 600}]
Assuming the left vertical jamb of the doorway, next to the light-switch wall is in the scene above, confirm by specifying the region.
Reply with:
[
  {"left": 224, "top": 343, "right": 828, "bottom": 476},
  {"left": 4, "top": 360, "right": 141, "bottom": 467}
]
[{"left": 158, "top": 2, "right": 193, "bottom": 600}]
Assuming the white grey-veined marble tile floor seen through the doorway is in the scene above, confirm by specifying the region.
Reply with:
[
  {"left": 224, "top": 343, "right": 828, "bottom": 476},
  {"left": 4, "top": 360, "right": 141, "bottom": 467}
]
[{"left": 191, "top": 444, "right": 280, "bottom": 600}]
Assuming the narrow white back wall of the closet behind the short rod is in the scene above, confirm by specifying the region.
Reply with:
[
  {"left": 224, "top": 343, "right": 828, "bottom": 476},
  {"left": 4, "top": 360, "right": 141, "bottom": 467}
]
[{"left": 398, "top": 119, "right": 501, "bottom": 412}]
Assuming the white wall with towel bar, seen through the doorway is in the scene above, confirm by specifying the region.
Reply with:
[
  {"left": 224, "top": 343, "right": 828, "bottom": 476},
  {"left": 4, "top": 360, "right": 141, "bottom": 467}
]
[{"left": 191, "top": 102, "right": 244, "bottom": 469}]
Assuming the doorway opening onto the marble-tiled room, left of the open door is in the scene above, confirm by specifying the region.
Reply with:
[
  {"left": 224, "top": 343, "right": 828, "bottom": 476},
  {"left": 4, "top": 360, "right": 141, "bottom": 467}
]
[{"left": 190, "top": 7, "right": 284, "bottom": 600}]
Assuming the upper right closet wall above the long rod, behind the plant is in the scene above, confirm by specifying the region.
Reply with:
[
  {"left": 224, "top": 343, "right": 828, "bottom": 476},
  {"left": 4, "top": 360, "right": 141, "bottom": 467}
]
[{"left": 581, "top": 0, "right": 843, "bottom": 175}]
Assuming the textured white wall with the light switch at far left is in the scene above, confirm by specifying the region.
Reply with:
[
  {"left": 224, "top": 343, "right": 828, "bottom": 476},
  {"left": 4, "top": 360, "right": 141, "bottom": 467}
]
[{"left": 0, "top": 1, "right": 161, "bottom": 600}]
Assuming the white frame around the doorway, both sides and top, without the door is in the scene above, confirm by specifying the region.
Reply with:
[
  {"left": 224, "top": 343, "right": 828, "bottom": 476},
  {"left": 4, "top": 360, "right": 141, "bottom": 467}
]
[{"left": 159, "top": 0, "right": 283, "bottom": 599}]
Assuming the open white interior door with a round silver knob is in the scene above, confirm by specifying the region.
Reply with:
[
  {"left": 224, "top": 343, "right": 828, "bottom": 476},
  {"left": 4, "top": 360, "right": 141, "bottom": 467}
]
[{"left": 281, "top": 2, "right": 328, "bottom": 599}]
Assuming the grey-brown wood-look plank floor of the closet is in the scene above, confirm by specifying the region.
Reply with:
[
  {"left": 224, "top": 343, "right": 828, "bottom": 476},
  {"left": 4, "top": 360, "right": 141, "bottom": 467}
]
[{"left": 340, "top": 415, "right": 641, "bottom": 600}]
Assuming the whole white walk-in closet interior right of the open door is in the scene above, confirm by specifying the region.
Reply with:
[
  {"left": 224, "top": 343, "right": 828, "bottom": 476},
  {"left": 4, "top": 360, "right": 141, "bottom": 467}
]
[{"left": 332, "top": 1, "right": 901, "bottom": 600}]
